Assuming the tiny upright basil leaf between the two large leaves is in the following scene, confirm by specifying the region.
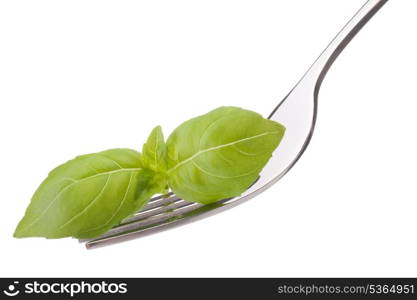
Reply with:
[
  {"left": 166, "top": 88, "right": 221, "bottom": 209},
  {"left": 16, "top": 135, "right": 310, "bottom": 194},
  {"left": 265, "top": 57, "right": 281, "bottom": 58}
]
[{"left": 142, "top": 126, "right": 166, "bottom": 172}]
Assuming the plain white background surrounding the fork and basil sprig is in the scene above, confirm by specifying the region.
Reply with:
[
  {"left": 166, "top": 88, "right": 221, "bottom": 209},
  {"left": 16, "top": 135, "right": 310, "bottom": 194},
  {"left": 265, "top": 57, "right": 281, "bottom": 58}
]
[{"left": 0, "top": 0, "right": 417, "bottom": 276}]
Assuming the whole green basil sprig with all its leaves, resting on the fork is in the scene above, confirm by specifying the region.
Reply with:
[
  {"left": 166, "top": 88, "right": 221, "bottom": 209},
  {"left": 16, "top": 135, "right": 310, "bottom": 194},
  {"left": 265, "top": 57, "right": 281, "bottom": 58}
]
[{"left": 14, "top": 107, "right": 285, "bottom": 238}]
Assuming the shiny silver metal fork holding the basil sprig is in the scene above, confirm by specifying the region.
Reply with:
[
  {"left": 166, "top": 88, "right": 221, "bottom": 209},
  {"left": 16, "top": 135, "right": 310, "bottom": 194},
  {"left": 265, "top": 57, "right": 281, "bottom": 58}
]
[{"left": 80, "top": 0, "right": 388, "bottom": 249}]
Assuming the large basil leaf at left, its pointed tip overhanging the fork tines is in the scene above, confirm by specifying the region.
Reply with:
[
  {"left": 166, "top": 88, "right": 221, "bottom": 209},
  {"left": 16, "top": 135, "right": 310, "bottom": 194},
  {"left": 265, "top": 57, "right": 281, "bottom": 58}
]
[{"left": 14, "top": 149, "right": 157, "bottom": 238}]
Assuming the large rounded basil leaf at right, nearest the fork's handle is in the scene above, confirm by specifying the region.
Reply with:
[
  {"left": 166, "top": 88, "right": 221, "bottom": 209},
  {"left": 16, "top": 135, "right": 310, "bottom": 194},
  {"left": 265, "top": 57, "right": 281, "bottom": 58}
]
[{"left": 167, "top": 107, "right": 285, "bottom": 204}]
